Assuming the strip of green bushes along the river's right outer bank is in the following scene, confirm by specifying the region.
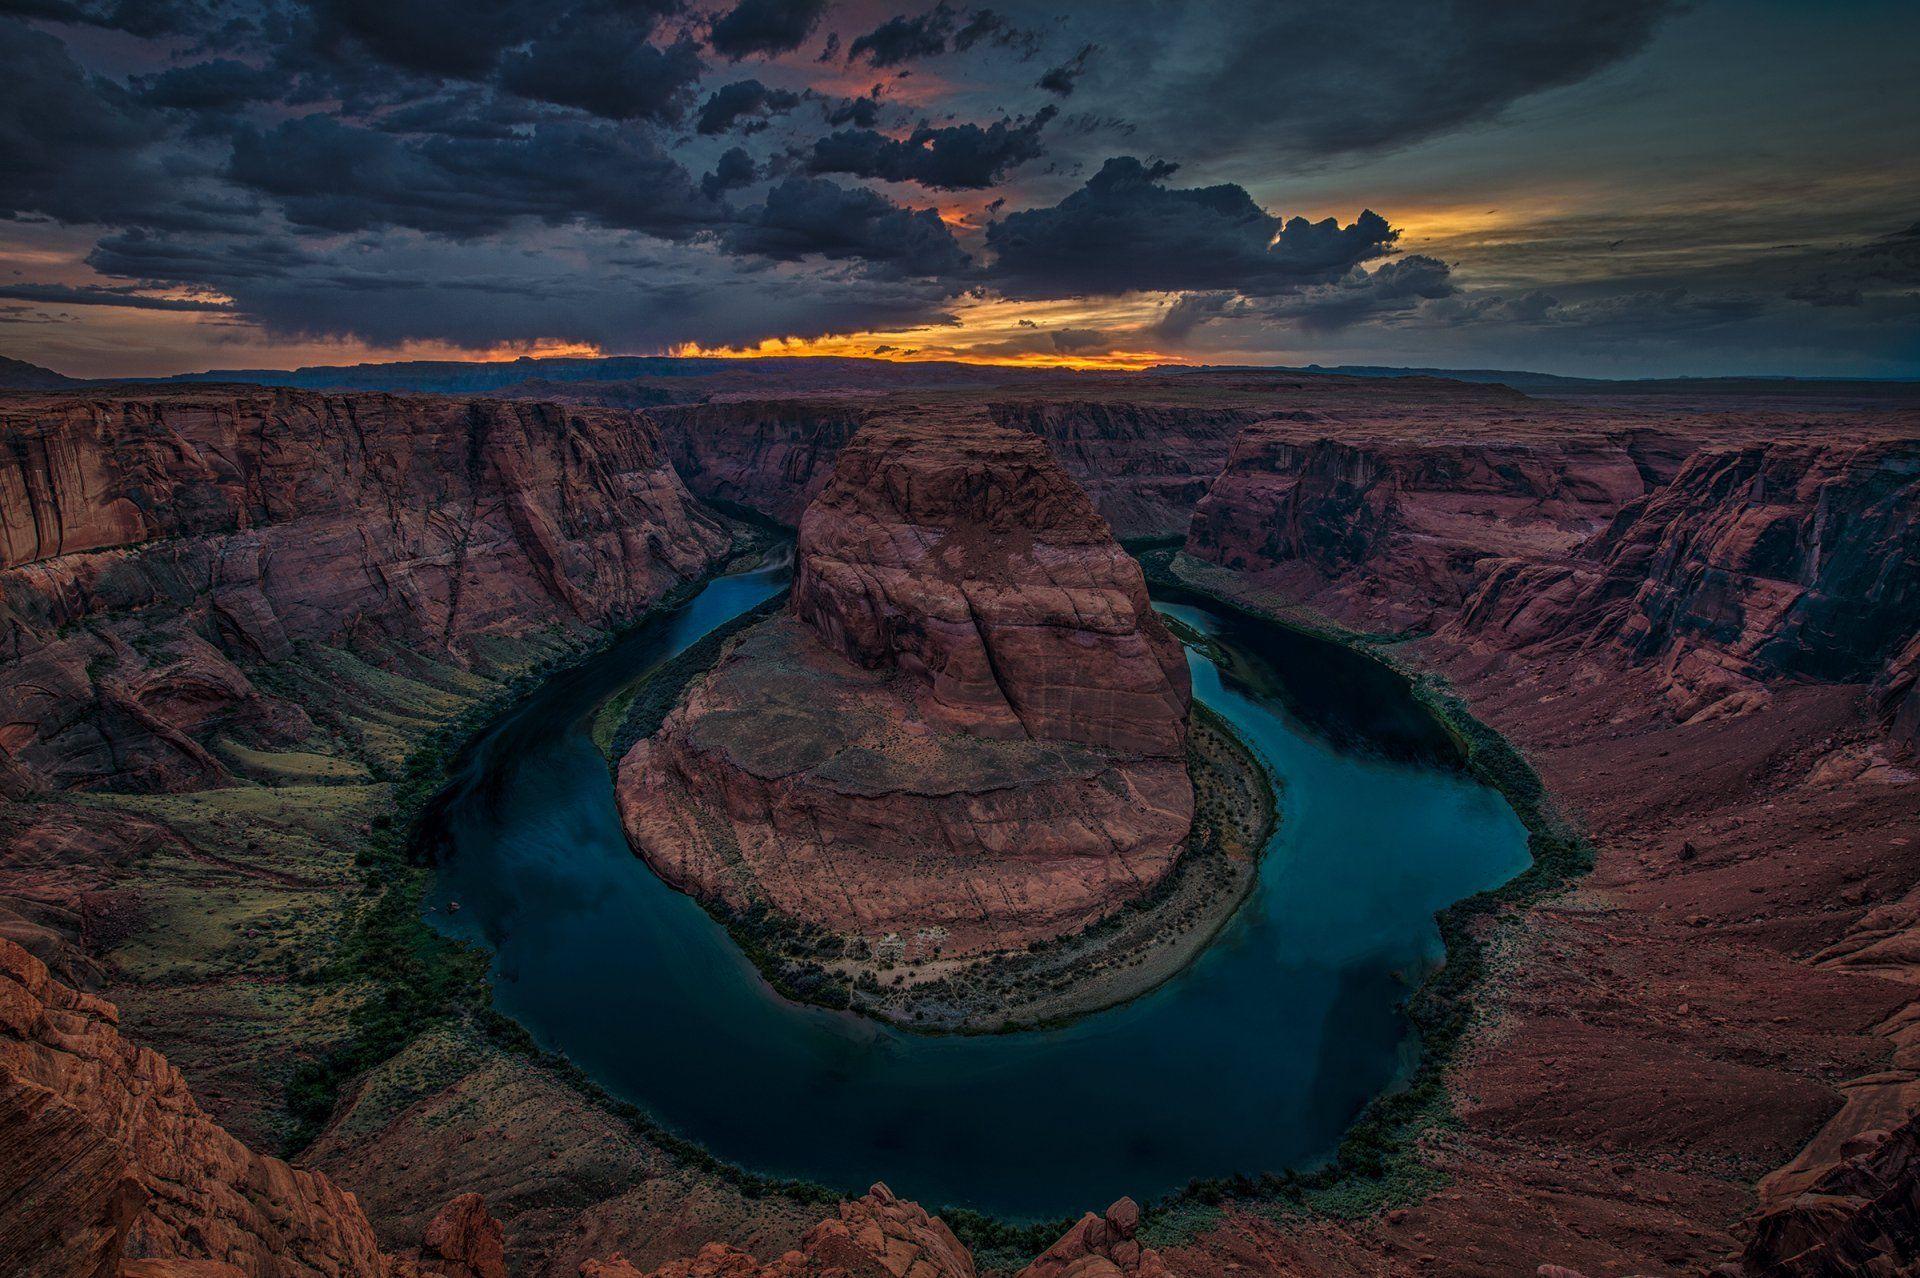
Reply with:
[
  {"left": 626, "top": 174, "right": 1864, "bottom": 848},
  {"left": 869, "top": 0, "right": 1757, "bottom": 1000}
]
[{"left": 1142, "top": 551, "right": 1594, "bottom": 1247}]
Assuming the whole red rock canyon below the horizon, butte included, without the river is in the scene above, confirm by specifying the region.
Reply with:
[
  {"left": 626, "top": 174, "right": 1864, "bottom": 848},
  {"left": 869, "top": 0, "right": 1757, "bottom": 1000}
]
[{"left": 0, "top": 370, "right": 1920, "bottom": 1278}]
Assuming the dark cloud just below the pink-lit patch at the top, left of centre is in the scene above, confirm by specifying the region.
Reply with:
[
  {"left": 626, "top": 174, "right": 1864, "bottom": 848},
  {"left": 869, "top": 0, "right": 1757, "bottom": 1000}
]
[{"left": 499, "top": 15, "right": 707, "bottom": 123}]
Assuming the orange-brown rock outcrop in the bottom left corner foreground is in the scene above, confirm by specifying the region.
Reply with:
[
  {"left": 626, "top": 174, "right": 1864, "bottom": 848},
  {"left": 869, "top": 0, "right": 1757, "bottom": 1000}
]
[{"left": 0, "top": 924, "right": 505, "bottom": 1278}]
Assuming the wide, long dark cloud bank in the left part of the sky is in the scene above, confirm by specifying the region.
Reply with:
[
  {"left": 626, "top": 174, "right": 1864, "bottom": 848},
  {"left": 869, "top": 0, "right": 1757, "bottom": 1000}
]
[{"left": 228, "top": 115, "right": 722, "bottom": 238}]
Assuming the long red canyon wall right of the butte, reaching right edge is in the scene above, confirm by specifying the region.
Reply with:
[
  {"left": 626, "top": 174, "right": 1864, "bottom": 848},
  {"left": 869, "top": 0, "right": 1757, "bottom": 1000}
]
[{"left": 1185, "top": 414, "right": 1920, "bottom": 725}]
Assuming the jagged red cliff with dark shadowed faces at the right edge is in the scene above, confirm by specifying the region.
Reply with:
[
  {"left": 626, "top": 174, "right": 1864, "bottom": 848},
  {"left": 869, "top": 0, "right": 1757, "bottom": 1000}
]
[{"left": 1453, "top": 441, "right": 1920, "bottom": 723}]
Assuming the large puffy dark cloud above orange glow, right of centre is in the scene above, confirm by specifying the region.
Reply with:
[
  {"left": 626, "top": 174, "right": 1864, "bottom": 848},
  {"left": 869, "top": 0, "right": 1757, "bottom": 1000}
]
[{"left": 987, "top": 157, "right": 1396, "bottom": 297}]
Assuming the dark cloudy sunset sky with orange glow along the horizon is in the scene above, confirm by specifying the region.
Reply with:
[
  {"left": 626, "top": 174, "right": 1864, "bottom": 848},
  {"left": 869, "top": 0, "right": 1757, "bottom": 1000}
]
[{"left": 0, "top": 0, "right": 1920, "bottom": 376}]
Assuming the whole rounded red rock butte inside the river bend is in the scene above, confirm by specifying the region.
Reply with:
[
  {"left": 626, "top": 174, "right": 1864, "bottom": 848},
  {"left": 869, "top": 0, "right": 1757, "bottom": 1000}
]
[{"left": 618, "top": 416, "right": 1192, "bottom": 954}]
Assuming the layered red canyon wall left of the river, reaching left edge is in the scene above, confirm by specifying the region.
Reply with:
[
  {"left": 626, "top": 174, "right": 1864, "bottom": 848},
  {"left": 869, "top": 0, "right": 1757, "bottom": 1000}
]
[{"left": 0, "top": 388, "right": 728, "bottom": 794}]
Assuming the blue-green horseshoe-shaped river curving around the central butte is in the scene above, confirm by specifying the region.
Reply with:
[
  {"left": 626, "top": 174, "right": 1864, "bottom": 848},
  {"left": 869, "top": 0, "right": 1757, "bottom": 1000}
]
[{"left": 426, "top": 568, "right": 1528, "bottom": 1219}]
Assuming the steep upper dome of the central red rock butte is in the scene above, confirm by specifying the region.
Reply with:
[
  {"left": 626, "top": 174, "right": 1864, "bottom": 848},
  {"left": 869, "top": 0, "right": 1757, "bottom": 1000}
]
[{"left": 793, "top": 420, "right": 1187, "bottom": 756}]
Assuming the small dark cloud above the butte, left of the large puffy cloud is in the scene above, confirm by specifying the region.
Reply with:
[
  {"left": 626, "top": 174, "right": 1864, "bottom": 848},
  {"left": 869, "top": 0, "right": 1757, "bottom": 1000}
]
[{"left": 726, "top": 177, "right": 968, "bottom": 276}]
